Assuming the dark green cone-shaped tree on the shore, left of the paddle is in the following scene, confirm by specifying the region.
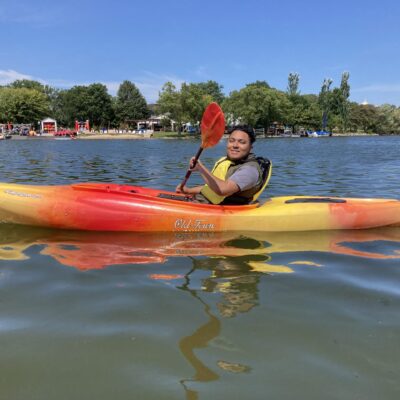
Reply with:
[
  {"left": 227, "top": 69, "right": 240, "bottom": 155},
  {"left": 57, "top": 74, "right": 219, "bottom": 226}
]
[{"left": 114, "top": 81, "right": 150, "bottom": 123}]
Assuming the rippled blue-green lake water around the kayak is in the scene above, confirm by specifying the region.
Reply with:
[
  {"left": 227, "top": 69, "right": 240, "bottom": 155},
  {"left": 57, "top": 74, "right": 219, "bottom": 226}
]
[{"left": 0, "top": 137, "right": 400, "bottom": 400}]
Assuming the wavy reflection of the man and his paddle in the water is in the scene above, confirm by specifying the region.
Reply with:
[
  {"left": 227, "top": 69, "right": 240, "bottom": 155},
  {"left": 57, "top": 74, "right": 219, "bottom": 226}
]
[{"left": 179, "top": 255, "right": 260, "bottom": 400}]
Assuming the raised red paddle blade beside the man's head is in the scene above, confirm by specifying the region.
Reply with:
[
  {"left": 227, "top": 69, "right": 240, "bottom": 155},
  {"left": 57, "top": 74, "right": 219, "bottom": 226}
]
[{"left": 200, "top": 103, "right": 225, "bottom": 149}]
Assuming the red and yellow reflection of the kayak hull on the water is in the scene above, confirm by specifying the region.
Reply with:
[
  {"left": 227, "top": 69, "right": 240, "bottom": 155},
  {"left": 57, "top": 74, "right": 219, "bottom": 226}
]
[{"left": 0, "top": 225, "right": 400, "bottom": 270}]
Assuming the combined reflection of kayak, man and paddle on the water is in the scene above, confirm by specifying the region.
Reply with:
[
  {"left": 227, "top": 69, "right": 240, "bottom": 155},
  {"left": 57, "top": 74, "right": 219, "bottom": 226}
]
[{"left": 0, "top": 225, "right": 400, "bottom": 400}]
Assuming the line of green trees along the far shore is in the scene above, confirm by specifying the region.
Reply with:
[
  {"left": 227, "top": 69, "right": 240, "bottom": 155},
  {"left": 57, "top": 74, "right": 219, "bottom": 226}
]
[{"left": 0, "top": 72, "right": 400, "bottom": 134}]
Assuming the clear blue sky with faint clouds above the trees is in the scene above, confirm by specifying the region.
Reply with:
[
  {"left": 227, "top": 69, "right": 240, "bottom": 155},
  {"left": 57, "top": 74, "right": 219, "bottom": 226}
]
[{"left": 0, "top": 0, "right": 400, "bottom": 106}]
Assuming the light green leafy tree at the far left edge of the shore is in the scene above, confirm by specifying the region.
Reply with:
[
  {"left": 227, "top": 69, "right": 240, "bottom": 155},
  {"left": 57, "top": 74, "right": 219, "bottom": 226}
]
[{"left": 0, "top": 87, "right": 50, "bottom": 125}]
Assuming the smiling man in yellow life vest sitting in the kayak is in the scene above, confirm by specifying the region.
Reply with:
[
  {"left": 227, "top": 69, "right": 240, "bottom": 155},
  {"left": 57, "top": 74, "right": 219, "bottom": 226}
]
[{"left": 176, "top": 125, "right": 271, "bottom": 205}]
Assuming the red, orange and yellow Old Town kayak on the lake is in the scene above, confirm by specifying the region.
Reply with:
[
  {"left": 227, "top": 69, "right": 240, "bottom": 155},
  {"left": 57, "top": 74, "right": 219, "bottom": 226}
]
[{"left": 0, "top": 183, "right": 400, "bottom": 232}]
